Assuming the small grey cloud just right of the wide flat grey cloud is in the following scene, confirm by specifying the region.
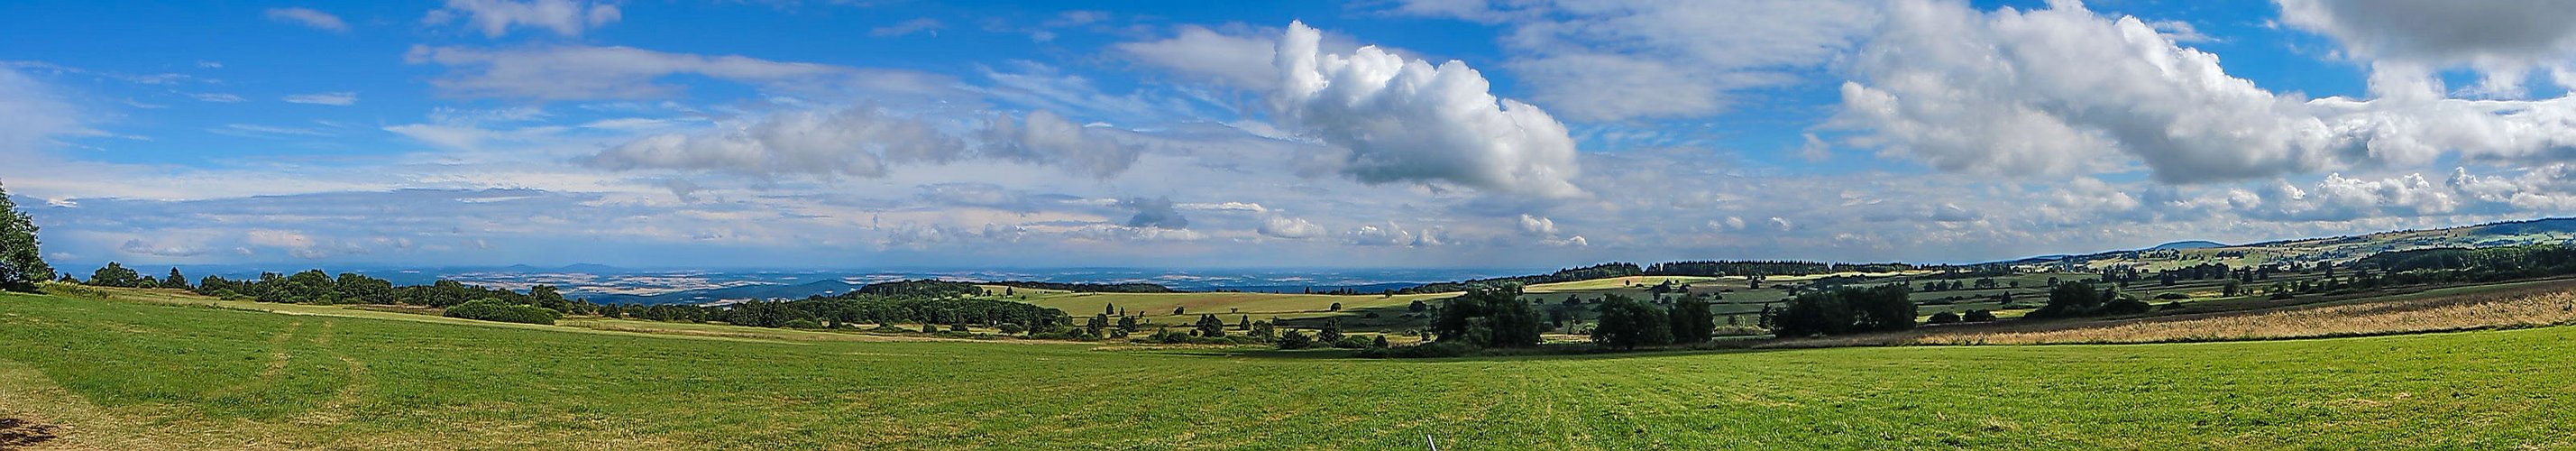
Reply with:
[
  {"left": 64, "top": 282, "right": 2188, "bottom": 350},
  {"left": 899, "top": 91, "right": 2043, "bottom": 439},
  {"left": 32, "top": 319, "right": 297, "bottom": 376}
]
[{"left": 982, "top": 111, "right": 1139, "bottom": 178}]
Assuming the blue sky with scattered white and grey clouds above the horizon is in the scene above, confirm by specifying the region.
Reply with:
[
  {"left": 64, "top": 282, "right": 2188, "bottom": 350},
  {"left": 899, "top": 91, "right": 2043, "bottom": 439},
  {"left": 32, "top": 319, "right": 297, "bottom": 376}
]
[{"left": 0, "top": 0, "right": 2576, "bottom": 268}]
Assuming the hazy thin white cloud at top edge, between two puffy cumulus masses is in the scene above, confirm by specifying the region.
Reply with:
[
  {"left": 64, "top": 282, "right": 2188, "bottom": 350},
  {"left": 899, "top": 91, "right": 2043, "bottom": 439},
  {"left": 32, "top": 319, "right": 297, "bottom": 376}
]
[{"left": 1396, "top": 0, "right": 1878, "bottom": 121}]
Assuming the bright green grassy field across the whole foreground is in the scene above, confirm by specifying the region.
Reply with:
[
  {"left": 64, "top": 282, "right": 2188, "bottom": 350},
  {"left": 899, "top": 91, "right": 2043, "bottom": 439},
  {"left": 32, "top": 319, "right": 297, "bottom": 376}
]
[{"left": 0, "top": 294, "right": 2576, "bottom": 448}]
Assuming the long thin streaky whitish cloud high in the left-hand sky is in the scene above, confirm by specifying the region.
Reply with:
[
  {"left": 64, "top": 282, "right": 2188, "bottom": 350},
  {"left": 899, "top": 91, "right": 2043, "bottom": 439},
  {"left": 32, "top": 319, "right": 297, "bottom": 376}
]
[{"left": 405, "top": 46, "right": 855, "bottom": 100}]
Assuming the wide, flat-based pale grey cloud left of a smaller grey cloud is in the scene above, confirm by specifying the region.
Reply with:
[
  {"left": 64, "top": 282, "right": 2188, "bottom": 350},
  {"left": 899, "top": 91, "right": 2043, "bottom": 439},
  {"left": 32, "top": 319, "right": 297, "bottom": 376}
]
[{"left": 585, "top": 106, "right": 966, "bottom": 178}]
